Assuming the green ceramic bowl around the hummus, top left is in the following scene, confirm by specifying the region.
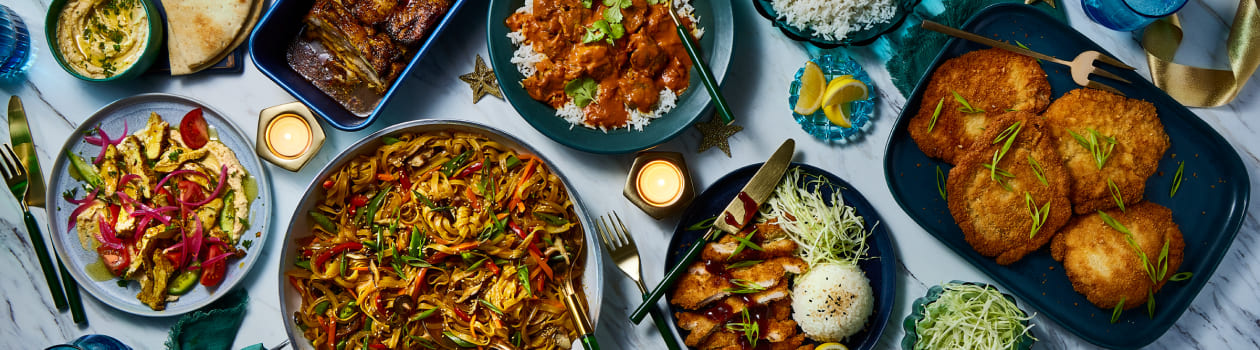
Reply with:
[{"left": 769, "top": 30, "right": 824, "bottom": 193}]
[{"left": 44, "top": 0, "right": 166, "bottom": 82}]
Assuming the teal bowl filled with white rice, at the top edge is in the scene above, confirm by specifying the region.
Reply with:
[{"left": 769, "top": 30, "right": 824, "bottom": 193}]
[{"left": 752, "top": 0, "right": 920, "bottom": 49}]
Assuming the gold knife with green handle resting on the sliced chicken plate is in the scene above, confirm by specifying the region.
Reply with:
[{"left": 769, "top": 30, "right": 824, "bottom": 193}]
[{"left": 630, "top": 138, "right": 796, "bottom": 324}]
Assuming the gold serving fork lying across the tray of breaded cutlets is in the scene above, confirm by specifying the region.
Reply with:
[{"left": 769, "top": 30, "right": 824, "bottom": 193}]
[{"left": 922, "top": 20, "right": 1135, "bottom": 96}]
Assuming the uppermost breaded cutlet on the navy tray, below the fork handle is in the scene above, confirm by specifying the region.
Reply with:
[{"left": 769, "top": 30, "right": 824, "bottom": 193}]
[{"left": 910, "top": 49, "right": 1051, "bottom": 164}]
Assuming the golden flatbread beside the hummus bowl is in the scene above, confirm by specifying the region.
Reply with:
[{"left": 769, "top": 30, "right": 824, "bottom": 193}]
[{"left": 163, "top": 0, "right": 261, "bottom": 76}]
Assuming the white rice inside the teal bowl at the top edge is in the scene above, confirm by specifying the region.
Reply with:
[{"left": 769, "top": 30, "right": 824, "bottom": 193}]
[{"left": 770, "top": 0, "right": 897, "bottom": 40}]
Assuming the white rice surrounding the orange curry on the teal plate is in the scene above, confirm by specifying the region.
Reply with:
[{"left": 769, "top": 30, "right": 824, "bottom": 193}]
[{"left": 508, "top": 0, "right": 704, "bottom": 132}]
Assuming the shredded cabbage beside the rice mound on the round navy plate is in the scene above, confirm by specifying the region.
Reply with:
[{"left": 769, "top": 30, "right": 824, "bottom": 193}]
[{"left": 761, "top": 167, "right": 871, "bottom": 266}]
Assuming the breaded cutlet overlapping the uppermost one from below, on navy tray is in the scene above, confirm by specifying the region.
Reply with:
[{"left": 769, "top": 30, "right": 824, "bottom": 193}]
[{"left": 948, "top": 112, "right": 1072, "bottom": 264}]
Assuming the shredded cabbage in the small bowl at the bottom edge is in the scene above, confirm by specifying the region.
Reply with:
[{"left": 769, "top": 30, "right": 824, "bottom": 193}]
[{"left": 915, "top": 283, "right": 1037, "bottom": 350}]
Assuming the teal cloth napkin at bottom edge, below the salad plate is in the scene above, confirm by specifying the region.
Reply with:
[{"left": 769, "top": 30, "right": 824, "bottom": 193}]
[{"left": 166, "top": 288, "right": 248, "bottom": 350}]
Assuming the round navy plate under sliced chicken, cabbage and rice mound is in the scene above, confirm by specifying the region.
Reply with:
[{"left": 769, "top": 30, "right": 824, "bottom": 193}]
[{"left": 665, "top": 162, "right": 897, "bottom": 350}]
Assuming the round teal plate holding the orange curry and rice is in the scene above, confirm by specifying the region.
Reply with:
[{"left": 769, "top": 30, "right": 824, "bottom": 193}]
[{"left": 486, "top": 0, "right": 738, "bottom": 154}]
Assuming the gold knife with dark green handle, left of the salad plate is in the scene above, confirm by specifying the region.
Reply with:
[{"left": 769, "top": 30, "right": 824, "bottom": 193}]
[{"left": 9, "top": 96, "right": 87, "bottom": 324}]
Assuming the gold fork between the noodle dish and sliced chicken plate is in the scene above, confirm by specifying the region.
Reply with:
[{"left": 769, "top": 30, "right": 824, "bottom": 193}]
[{"left": 595, "top": 212, "right": 678, "bottom": 350}]
